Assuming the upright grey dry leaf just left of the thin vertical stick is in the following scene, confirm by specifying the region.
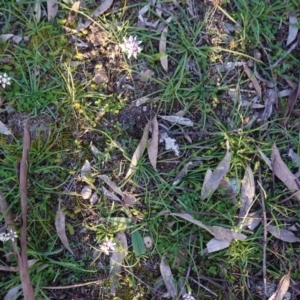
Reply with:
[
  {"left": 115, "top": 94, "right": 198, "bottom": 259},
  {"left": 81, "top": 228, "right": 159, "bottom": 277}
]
[{"left": 239, "top": 165, "right": 255, "bottom": 227}]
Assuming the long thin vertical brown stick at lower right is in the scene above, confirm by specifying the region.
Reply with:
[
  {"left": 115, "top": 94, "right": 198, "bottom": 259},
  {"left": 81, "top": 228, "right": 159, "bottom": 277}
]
[{"left": 257, "top": 167, "right": 268, "bottom": 300}]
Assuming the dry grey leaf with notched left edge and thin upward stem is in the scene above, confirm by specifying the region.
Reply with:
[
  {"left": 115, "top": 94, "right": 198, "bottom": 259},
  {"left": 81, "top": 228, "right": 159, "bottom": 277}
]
[{"left": 201, "top": 141, "right": 231, "bottom": 200}]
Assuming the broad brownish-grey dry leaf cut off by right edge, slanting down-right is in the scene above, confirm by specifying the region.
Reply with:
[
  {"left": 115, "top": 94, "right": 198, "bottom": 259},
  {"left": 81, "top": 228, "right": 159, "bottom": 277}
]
[{"left": 271, "top": 144, "right": 300, "bottom": 200}]
